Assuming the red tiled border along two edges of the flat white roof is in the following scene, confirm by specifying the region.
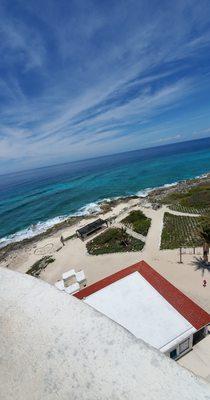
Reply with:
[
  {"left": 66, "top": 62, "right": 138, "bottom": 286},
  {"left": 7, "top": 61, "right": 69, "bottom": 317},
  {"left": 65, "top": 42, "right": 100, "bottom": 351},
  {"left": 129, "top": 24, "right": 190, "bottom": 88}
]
[{"left": 74, "top": 261, "right": 210, "bottom": 330}]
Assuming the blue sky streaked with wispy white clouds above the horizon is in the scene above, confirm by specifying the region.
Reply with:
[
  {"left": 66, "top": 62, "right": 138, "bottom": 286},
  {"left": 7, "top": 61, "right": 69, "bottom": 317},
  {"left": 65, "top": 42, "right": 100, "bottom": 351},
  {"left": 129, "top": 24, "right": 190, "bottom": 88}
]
[{"left": 0, "top": 0, "right": 210, "bottom": 173}]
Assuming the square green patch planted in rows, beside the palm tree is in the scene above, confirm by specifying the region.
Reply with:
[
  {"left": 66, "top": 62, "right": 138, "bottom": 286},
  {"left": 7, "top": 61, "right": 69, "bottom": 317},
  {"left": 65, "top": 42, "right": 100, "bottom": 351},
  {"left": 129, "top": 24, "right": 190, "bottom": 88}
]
[{"left": 161, "top": 213, "right": 202, "bottom": 249}]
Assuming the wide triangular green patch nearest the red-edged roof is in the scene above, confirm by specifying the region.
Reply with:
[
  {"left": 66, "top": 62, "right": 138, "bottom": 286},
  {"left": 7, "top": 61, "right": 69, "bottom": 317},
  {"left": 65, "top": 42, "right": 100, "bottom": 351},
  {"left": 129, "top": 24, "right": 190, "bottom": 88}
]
[{"left": 86, "top": 228, "right": 144, "bottom": 255}]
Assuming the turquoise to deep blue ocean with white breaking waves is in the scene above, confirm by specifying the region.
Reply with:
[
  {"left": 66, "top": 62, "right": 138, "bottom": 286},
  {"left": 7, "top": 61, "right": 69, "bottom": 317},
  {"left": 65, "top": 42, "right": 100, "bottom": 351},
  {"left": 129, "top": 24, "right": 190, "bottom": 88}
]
[{"left": 0, "top": 138, "right": 210, "bottom": 246}]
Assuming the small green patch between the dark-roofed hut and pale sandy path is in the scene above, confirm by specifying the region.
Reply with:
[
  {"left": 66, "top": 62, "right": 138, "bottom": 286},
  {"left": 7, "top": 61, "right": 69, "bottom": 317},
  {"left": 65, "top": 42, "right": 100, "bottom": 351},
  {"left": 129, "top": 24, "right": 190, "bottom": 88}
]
[{"left": 121, "top": 210, "right": 151, "bottom": 236}]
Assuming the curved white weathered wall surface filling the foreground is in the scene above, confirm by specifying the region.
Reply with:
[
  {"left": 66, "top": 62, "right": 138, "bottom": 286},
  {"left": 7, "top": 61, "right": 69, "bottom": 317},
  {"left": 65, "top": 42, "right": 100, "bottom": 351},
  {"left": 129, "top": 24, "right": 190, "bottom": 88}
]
[{"left": 0, "top": 268, "right": 210, "bottom": 400}]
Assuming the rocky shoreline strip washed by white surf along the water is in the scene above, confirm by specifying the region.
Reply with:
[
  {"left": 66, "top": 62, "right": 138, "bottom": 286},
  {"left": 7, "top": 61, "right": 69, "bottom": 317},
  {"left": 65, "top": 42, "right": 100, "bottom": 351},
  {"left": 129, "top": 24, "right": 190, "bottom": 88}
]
[{"left": 0, "top": 172, "right": 210, "bottom": 261}]
